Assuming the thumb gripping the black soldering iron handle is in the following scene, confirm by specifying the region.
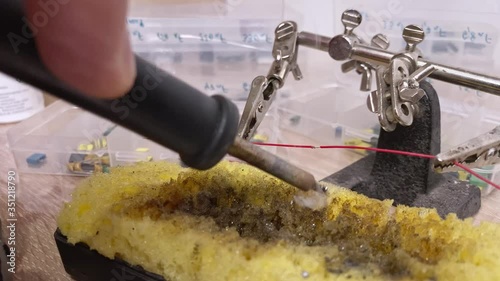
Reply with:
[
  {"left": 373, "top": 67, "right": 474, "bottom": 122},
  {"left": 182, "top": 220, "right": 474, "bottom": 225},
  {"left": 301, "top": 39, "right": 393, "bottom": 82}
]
[{"left": 26, "top": 0, "right": 136, "bottom": 98}]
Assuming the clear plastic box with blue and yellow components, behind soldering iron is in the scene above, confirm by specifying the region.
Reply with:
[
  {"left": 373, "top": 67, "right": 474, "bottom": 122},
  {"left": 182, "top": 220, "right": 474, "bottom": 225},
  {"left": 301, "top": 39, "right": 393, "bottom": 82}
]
[{"left": 7, "top": 98, "right": 282, "bottom": 176}]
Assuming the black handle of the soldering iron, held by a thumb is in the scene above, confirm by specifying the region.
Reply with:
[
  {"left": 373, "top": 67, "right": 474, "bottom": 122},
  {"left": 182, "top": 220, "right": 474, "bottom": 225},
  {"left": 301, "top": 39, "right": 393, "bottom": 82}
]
[{"left": 0, "top": 0, "right": 239, "bottom": 170}]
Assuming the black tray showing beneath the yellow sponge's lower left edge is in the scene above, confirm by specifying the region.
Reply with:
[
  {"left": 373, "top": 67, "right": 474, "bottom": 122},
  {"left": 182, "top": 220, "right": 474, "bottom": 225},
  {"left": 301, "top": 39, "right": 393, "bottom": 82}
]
[{"left": 54, "top": 230, "right": 164, "bottom": 281}]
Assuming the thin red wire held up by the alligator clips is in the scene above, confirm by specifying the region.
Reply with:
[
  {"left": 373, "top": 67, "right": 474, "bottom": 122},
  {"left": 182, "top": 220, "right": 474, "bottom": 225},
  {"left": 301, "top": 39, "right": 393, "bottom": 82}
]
[{"left": 254, "top": 142, "right": 500, "bottom": 189}]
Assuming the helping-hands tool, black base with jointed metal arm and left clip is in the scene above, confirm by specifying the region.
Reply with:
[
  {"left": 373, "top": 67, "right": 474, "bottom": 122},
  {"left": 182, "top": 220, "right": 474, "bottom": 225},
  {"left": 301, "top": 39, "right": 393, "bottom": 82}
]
[{"left": 238, "top": 10, "right": 500, "bottom": 218}]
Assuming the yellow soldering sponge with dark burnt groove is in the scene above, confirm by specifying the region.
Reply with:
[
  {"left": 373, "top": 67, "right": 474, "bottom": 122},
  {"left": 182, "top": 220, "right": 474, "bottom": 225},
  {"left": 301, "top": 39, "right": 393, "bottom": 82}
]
[{"left": 58, "top": 162, "right": 500, "bottom": 281}]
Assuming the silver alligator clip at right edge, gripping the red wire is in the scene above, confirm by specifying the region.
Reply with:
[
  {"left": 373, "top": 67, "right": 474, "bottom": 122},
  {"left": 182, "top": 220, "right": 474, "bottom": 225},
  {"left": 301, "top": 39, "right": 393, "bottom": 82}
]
[{"left": 434, "top": 126, "right": 500, "bottom": 172}]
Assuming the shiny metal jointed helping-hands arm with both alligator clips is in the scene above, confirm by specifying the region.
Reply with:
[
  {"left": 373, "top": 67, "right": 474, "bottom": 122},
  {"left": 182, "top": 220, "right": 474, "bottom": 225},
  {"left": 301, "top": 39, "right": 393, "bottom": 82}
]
[{"left": 239, "top": 10, "right": 500, "bottom": 172}]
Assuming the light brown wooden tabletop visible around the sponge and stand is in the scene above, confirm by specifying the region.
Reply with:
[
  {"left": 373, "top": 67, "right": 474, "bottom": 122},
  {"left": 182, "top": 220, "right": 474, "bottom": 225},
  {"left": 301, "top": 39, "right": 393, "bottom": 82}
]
[{"left": 0, "top": 121, "right": 500, "bottom": 281}]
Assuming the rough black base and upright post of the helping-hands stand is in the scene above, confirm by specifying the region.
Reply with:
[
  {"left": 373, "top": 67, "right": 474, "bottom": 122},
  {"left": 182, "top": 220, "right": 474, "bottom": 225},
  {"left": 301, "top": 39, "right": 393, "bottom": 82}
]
[{"left": 324, "top": 82, "right": 481, "bottom": 218}]
